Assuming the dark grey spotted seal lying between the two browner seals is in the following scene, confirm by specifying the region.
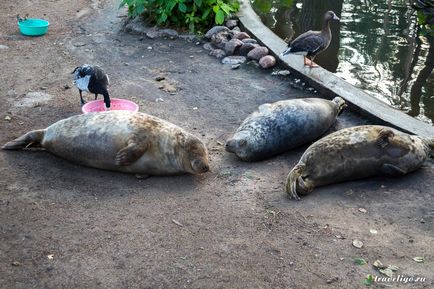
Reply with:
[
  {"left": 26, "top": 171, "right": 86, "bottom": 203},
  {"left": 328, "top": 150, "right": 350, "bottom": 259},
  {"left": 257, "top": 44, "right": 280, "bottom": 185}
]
[{"left": 226, "top": 97, "right": 345, "bottom": 161}]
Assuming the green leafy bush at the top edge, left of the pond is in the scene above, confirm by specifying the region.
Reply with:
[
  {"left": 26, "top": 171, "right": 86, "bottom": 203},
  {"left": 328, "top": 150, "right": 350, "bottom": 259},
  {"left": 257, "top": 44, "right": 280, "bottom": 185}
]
[{"left": 120, "top": 0, "right": 239, "bottom": 32}]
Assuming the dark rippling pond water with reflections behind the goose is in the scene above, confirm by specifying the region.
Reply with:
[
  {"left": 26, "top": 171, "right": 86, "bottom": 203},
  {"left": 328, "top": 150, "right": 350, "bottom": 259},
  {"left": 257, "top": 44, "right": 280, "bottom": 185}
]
[{"left": 252, "top": 0, "right": 434, "bottom": 123}]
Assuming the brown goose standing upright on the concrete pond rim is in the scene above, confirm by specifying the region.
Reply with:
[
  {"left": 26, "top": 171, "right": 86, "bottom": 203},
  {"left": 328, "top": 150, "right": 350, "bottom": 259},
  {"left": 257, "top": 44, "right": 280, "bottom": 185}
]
[{"left": 281, "top": 11, "right": 340, "bottom": 68}]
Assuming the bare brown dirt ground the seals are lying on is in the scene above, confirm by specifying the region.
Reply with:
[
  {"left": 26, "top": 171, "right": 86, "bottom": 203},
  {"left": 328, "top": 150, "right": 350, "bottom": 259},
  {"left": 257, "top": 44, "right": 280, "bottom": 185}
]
[{"left": 0, "top": 0, "right": 434, "bottom": 289}]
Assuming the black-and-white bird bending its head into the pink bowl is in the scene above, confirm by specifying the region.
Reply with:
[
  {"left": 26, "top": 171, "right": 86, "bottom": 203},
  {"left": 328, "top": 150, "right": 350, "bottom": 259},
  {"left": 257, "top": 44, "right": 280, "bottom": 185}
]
[{"left": 72, "top": 64, "right": 110, "bottom": 109}]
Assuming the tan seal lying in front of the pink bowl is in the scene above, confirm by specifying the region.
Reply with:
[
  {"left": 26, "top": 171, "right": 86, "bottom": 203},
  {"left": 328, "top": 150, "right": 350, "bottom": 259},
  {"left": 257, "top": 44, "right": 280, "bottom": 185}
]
[{"left": 2, "top": 111, "right": 209, "bottom": 175}]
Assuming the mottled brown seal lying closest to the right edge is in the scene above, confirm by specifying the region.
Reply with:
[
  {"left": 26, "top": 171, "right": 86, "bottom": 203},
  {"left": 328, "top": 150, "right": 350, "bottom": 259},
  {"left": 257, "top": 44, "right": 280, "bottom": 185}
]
[{"left": 286, "top": 125, "right": 434, "bottom": 199}]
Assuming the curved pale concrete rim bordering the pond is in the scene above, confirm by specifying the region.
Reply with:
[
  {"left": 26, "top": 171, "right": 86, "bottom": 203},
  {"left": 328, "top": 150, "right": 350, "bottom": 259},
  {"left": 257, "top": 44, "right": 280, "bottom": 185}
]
[{"left": 237, "top": 0, "right": 434, "bottom": 138}]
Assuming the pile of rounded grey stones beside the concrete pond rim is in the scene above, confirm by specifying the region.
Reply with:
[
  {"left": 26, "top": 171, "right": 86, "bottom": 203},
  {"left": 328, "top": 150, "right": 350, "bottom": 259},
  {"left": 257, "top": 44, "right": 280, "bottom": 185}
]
[{"left": 203, "top": 20, "right": 276, "bottom": 69}]
